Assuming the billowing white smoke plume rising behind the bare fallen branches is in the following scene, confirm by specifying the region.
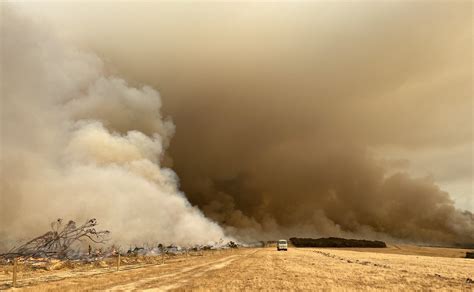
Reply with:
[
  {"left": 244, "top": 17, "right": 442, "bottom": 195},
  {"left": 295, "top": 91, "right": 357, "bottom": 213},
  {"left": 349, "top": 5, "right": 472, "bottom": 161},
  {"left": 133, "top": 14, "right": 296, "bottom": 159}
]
[{"left": 0, "top": 5, "right": 230, "bottom": 249}]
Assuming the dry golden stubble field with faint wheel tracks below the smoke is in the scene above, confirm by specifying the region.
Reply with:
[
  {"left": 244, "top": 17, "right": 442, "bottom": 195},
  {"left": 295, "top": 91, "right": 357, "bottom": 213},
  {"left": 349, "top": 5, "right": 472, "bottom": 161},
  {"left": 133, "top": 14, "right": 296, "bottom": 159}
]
[{"left": 4, "top": 248, "right": 474, "bottom": 291}]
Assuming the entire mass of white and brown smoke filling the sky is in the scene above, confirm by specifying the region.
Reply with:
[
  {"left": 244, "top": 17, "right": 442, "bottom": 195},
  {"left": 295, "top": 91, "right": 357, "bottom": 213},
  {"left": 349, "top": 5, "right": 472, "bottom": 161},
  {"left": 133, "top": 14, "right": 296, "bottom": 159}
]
[{"left": 0, "top": 2, "right": 474, "bottom": 249}]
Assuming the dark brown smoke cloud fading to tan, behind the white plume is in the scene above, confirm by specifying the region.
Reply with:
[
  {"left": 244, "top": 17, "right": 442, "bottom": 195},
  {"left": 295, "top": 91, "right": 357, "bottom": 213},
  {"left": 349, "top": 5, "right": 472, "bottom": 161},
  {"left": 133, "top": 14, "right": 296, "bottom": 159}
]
[{"left": 14, "top": 1, "right": 474, "bottom": 244}]
